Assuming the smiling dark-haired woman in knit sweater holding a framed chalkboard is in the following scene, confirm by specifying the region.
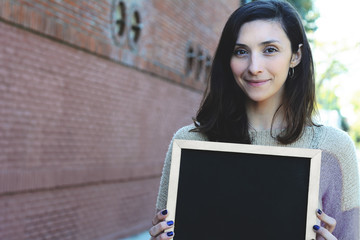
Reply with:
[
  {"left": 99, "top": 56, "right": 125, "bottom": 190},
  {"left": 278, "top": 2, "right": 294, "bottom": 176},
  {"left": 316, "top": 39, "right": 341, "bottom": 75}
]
[{"left": 149, "top": 1, "right": 359, "bottom": 240}]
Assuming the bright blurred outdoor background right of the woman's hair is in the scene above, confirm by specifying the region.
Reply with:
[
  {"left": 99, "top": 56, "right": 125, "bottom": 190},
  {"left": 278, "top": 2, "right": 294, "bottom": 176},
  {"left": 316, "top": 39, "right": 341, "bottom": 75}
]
[{"left": 309, "top": 0, "right": 360, "bottom": 148}]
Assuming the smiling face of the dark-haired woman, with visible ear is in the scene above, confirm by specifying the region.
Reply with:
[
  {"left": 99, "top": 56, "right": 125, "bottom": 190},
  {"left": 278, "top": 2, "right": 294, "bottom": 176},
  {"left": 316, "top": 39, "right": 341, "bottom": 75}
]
[{"left": 230, "top": 20, "right": 301, "bottom": 103}]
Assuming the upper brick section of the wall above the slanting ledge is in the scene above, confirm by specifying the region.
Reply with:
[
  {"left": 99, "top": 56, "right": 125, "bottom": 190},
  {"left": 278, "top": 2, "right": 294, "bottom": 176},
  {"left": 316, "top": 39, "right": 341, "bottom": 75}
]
[{"left": 1, "top": 0, "right": 239, "bottom": 89}]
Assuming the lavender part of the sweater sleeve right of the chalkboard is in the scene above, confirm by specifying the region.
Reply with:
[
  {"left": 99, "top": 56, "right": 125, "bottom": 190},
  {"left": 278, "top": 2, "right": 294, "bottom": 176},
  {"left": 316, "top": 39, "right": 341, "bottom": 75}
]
[{"left": 320, "top": 151, "right": 359, "bottom": 240}]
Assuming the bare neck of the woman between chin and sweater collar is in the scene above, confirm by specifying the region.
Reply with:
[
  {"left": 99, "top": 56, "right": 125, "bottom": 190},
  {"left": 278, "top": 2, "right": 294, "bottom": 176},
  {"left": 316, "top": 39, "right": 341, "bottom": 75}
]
[{"left": 246, "top": 100, "right": 286, "bottom": 131}]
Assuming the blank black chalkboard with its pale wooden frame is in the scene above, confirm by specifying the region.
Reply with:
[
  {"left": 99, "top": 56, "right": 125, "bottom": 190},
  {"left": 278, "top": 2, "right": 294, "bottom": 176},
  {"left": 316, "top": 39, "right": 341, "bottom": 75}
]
[{"left": 167, "top": 140, "right": 321, "bottom": 240}]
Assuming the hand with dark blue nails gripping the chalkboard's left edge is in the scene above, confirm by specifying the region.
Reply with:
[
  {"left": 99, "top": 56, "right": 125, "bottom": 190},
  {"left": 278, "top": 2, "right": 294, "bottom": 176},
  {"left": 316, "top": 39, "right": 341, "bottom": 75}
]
[{"left": 149, "top": 209, "right": 174, "bottom": 240}]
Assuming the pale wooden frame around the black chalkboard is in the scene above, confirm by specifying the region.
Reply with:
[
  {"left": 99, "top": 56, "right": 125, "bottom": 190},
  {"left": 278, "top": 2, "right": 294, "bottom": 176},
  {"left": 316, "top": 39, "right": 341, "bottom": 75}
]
[{"left": 167, "top": 139, "right": 321, "bottom": 240}]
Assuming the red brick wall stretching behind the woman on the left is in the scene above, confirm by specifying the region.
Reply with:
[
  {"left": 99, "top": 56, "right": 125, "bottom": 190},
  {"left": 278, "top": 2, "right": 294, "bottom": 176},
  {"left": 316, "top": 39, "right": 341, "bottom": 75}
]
[{"left": 0, "top": 0, "right": 239, "bottom": 239}]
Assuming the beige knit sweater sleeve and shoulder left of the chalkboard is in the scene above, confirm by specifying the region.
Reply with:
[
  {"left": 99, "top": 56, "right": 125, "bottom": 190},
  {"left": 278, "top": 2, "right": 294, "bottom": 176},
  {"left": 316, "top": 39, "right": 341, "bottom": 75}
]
[{"left": 156, "top": 125, "right": 206, "bottom": 210}]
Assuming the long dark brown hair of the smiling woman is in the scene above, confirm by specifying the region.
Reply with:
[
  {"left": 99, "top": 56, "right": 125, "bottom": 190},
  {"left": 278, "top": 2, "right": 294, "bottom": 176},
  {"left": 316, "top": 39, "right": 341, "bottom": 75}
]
[{"left": 192, "top": 0, "right": 316, "bottom": 144}]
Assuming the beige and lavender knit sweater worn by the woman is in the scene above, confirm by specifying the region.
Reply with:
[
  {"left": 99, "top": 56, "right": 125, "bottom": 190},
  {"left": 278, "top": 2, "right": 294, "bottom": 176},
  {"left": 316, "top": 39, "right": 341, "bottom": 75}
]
[{"left": 156, "top": 125, "right": 360, "bottom": 240}]
